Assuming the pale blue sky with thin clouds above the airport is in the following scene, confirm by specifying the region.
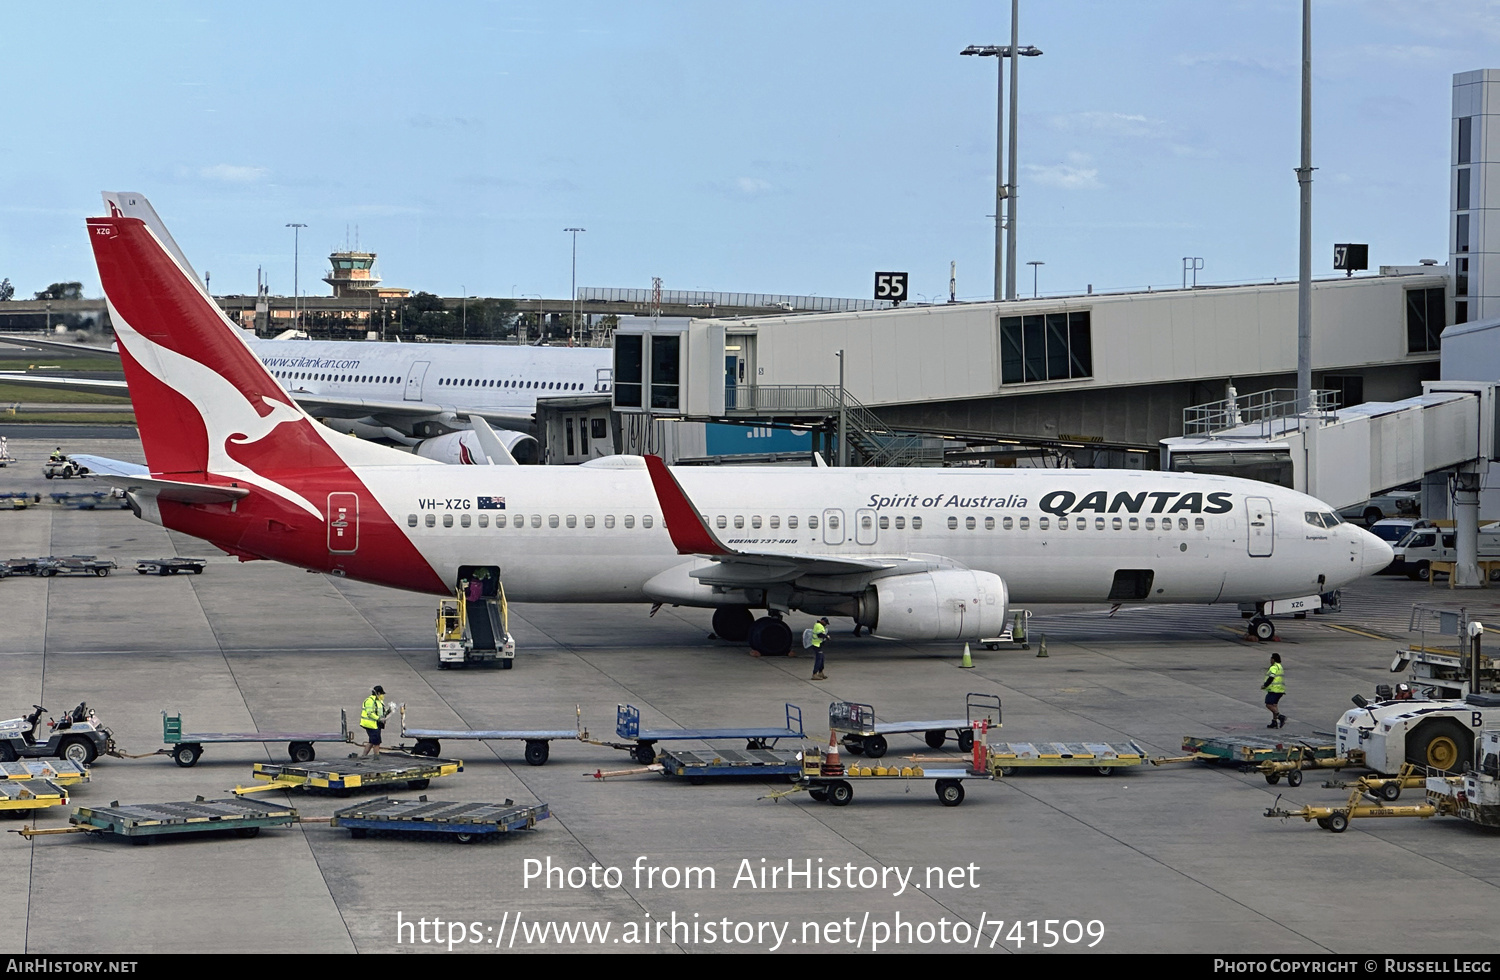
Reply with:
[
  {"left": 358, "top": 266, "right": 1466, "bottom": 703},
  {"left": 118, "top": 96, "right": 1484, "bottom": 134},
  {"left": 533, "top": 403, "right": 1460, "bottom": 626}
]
[{"left": 0, "top": 0, "right": 1500, "bottom": 302}]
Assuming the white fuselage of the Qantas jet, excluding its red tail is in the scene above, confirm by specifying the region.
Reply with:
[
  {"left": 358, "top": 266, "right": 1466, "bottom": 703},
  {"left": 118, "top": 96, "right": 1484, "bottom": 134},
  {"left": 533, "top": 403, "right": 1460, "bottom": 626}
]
[{"left": 337, "top": 458, "right": 1391, "bottom": 605}]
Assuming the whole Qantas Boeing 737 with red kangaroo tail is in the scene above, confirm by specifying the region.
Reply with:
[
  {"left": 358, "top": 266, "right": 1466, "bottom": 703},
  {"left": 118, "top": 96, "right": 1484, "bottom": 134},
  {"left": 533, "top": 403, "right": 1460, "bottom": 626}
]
[{"left": 89, "top": 208, "right": 1392, "bottom": 654}]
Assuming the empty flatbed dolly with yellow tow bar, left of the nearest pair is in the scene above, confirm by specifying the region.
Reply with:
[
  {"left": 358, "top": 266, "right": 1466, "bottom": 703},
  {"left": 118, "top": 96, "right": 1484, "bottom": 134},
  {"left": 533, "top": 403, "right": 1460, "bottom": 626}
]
[{"left": 15, "top": 797, "right": 297, "bottom": 843}]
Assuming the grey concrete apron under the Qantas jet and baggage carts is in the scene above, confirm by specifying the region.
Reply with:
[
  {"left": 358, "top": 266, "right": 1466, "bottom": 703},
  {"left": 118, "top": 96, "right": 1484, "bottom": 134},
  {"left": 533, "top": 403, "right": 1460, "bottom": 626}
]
[{"left": 0, "top": 426, "right": 1500, "bottom": 954}]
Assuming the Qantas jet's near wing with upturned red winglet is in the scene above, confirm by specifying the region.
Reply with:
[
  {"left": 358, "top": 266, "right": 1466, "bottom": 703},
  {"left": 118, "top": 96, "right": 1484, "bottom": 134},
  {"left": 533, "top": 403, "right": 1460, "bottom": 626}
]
[{"left": 645, "top": 456, "right": 953, "bottom": 587}]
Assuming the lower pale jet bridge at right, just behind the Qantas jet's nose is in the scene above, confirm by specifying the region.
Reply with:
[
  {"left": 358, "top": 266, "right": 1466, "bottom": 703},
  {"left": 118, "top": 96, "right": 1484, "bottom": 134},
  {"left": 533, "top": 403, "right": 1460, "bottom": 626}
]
[{"left": 1161, "top": 381, "right": 1500, "bottom": 587}]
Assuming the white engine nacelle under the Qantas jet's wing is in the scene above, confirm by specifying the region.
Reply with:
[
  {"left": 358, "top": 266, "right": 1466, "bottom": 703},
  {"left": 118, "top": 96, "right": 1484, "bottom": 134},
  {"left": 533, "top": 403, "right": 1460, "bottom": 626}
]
[{"left": 857, "top": 569, "right": 1010, "bottom": 639}]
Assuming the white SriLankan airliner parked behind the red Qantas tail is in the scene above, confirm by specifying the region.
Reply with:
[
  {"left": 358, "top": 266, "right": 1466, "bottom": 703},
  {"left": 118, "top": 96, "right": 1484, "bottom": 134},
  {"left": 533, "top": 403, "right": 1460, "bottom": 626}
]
[{"left": 0, "top": 191, "right": 614, "bottom": 464}]
